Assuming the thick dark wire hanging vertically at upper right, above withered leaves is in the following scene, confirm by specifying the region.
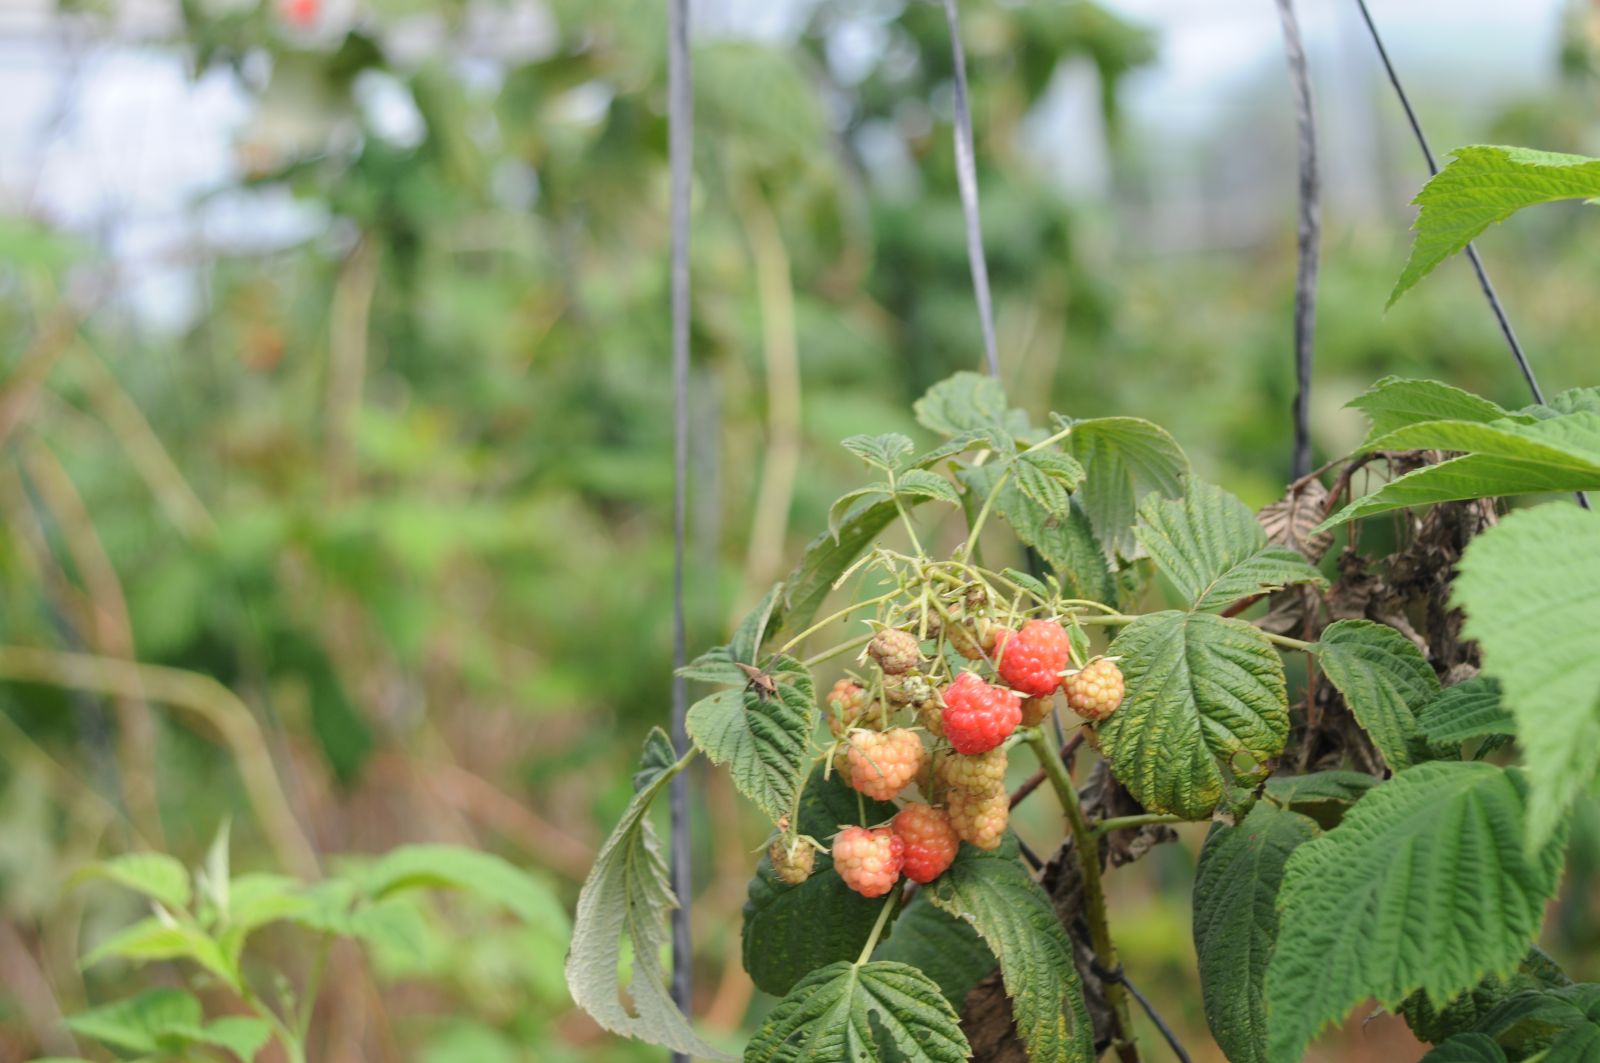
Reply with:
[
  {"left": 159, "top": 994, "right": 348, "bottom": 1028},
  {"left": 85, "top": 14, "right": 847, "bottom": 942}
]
[{"left": 1277, "top": 0, "right": 1322, "bottom": 480}]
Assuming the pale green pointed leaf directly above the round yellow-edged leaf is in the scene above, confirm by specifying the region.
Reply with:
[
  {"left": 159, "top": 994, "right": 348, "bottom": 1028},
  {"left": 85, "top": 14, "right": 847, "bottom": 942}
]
[{"left": 1134, "top": 480, "right": 1328, "bottom": 612}]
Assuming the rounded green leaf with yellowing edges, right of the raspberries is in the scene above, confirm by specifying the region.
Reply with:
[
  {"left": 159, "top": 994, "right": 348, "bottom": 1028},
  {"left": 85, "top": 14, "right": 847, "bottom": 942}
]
[{"left": 1099, "top": 610, "right": 1290, "bottom": 820}]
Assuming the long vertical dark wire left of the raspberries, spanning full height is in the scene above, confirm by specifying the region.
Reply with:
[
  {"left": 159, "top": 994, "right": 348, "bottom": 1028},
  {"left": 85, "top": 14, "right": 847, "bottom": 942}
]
[{"left": 667, "top": 0, "right": 694, "bottom": 1063}]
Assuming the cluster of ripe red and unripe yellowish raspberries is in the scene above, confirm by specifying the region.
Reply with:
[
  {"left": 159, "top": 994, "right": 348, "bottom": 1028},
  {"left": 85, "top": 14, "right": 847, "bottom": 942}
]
[{"left": 784, "top": 620, "right": 1123, "bottom": 897}]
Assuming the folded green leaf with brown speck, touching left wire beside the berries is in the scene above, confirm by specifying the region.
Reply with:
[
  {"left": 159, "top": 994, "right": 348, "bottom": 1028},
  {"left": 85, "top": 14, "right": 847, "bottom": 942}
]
[{"left": 686, "top": 656, "right": 818, "bottom": 823}]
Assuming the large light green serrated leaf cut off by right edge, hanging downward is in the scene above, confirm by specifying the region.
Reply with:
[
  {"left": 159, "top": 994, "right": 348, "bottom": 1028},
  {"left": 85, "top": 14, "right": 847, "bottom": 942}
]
[{"left": 1451, "top": 503, "right": 1600, "bottom": 845}]
